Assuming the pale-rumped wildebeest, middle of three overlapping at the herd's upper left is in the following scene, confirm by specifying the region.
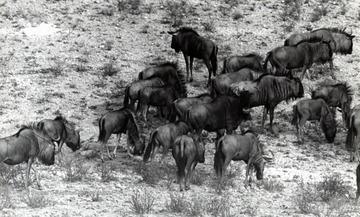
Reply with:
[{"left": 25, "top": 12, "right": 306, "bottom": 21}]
[{"left": 123, "top": 77, "right": 165, "bottom": 111}]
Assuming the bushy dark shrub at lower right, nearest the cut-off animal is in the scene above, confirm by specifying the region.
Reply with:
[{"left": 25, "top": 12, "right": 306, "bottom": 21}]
[{"left": 316, "top": 173, "right": 348, "bottom": 202}]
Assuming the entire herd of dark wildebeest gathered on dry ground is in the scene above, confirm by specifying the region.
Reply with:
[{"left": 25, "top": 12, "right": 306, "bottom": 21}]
[{"left": 0, "top": 27, "right": 360, "bottom": 198}]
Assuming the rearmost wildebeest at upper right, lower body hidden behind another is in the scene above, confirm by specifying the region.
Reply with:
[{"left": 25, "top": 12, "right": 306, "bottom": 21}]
[{"left": 285, "top": 28, "right": 355, "bottom": 54}]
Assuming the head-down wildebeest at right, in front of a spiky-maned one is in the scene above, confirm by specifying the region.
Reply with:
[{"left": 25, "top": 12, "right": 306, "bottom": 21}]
[{"left": 291, "top": 98, "right": 337, "bottom": 143}]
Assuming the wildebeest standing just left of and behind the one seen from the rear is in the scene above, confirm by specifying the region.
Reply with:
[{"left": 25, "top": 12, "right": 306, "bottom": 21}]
[{"left": 143, "top": 121, "right": 190, "bottom": 162}]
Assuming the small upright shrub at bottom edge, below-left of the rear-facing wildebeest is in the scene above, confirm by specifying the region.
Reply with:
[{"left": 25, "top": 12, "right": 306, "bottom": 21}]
[{"left": 130, "top": 191, "right": 155, "bottom": 214}]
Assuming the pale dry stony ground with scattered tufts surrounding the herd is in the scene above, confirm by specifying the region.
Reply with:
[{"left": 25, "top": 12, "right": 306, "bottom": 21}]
[{"left": 0, "top": 0, "right": 360, "bottom": 216}]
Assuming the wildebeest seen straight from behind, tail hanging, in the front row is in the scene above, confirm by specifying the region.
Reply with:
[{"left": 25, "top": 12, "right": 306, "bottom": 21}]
[{"left": 172, "top": 135, "right": 205, "bottom": 191}]
